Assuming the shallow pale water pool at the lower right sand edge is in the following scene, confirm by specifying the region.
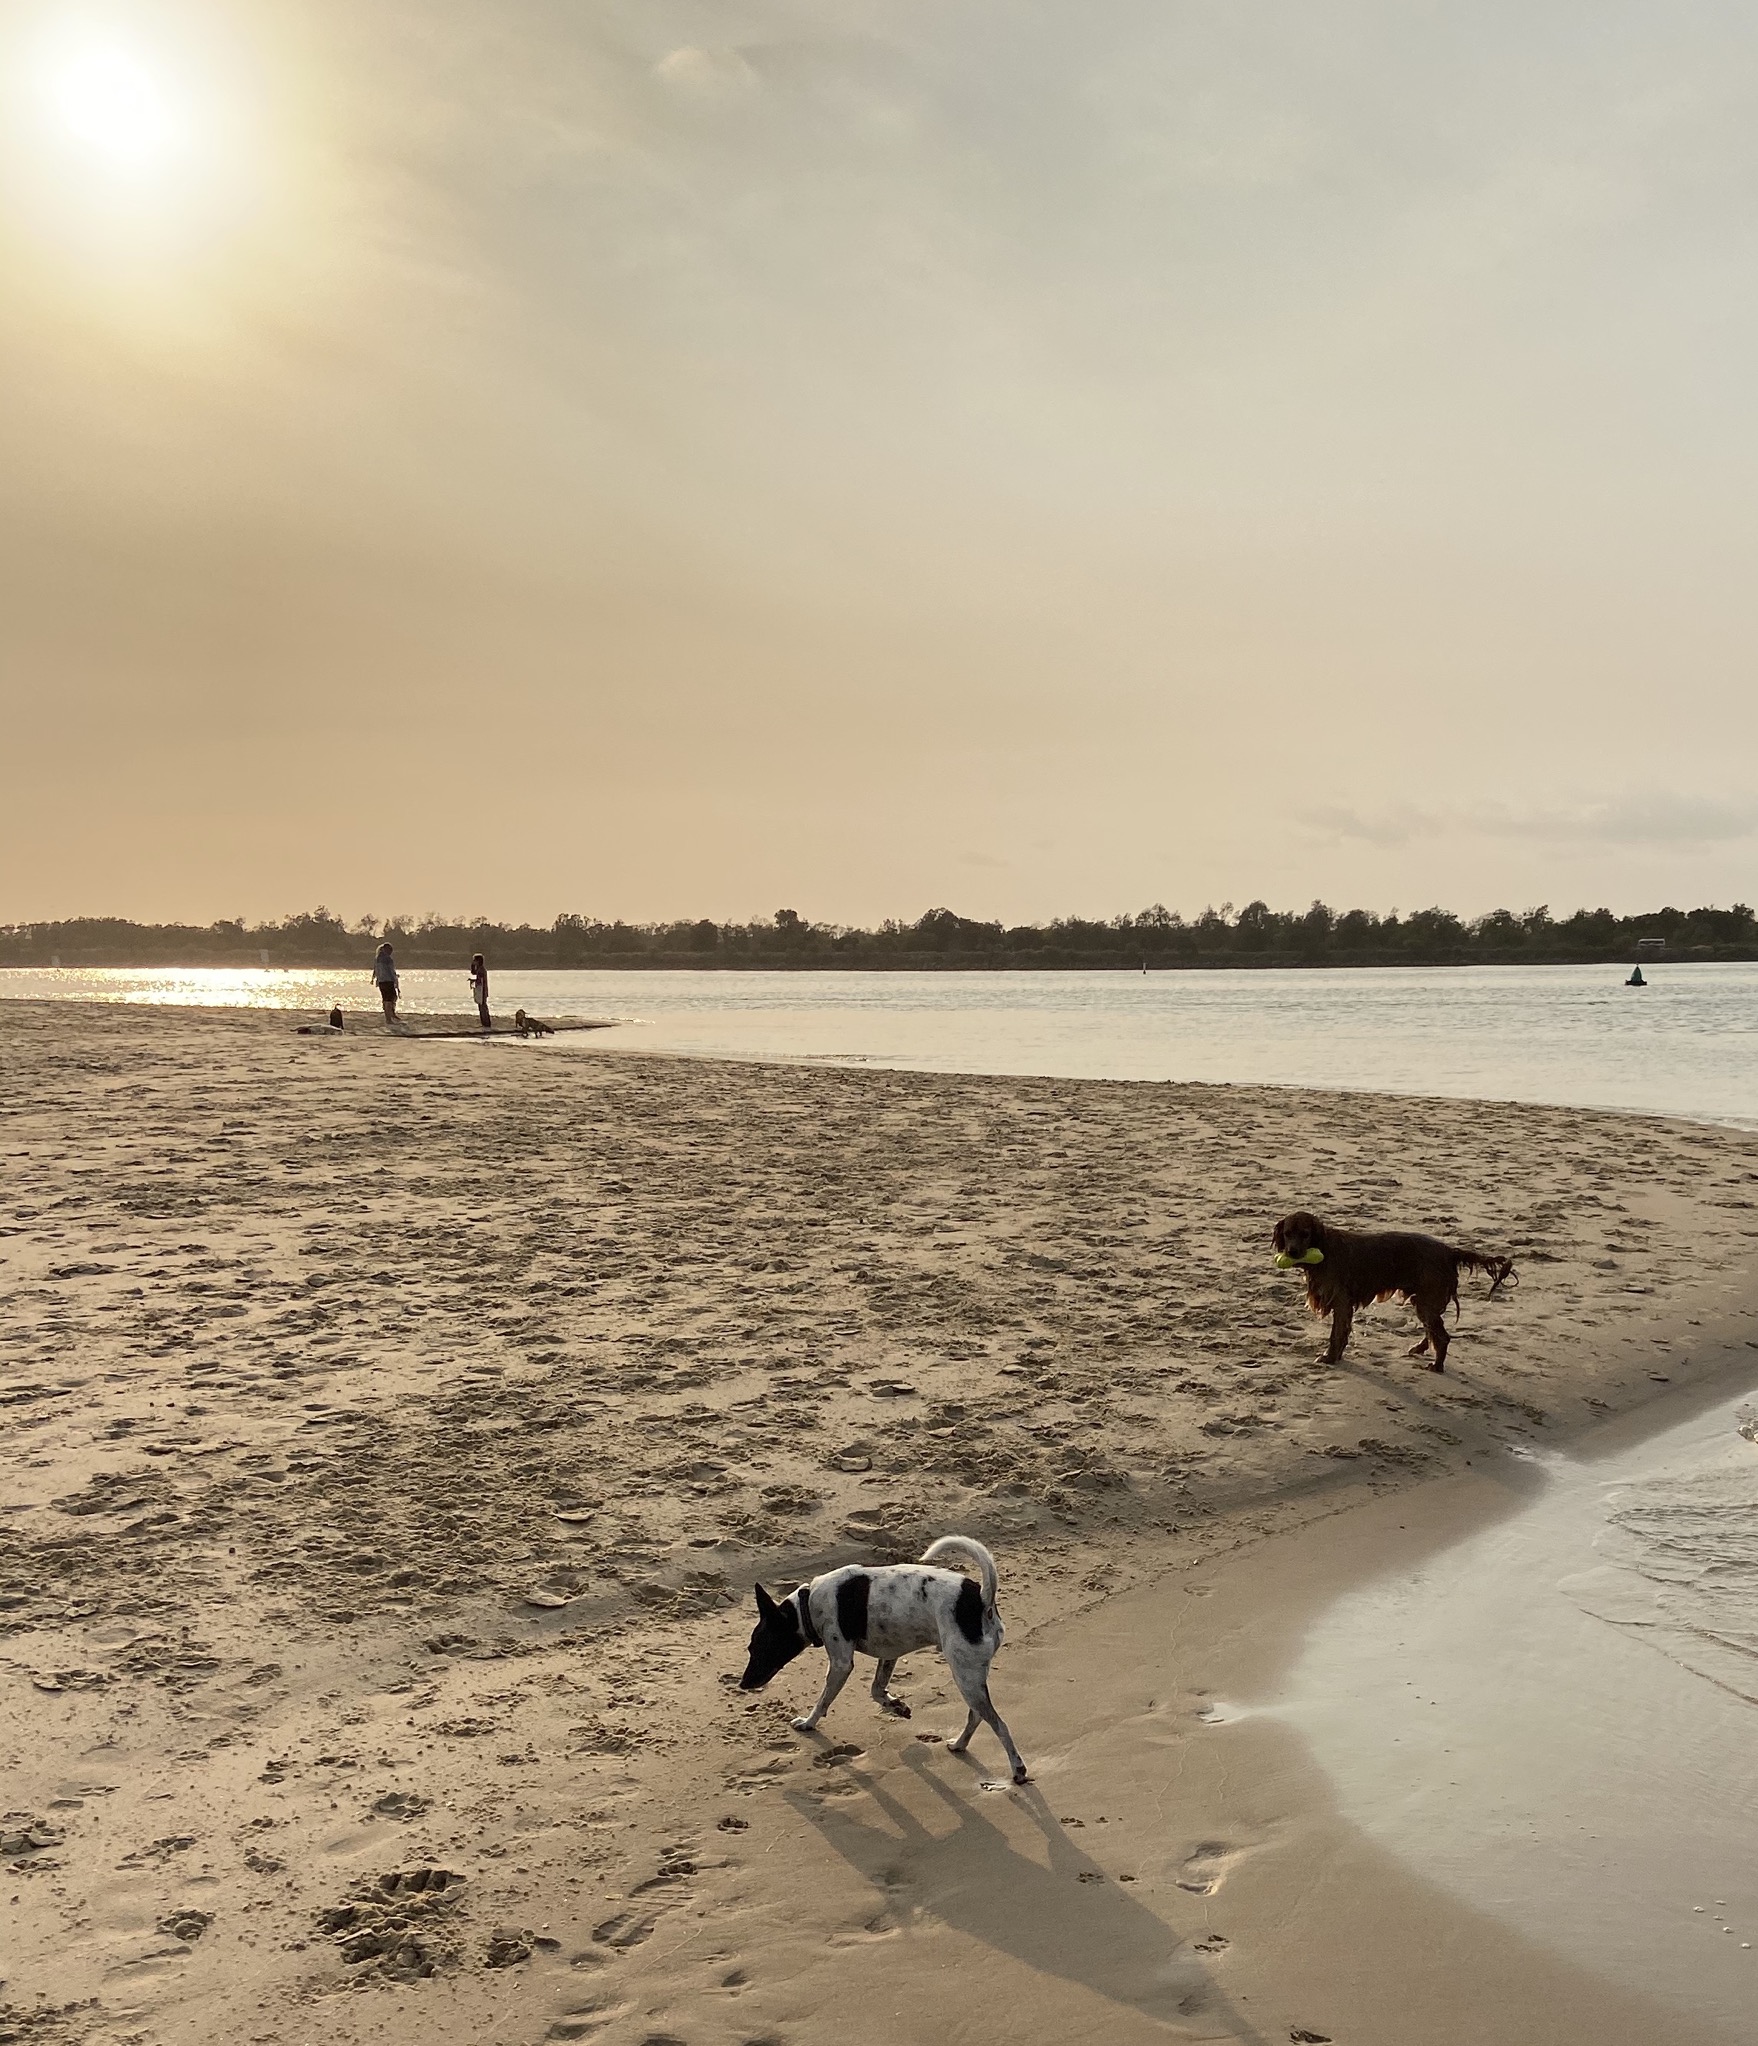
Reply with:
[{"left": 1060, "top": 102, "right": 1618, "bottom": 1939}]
[{"left": 1269, "top": 1395, "right": 1758, "bottom": 2038}]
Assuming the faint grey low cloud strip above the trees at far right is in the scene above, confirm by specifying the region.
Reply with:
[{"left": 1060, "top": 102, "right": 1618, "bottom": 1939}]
[{"left": 1298, "top": 790, "right": 1758, "bottom": 847}]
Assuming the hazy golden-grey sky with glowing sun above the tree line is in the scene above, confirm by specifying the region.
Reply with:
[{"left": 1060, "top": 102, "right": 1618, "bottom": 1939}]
[{"left": 0, "top": 0, "right": 1758, "bottom": 921}]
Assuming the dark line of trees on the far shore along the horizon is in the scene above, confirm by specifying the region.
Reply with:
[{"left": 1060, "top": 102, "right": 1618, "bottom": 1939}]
[{"left": 0, "top": 902, "right": 1758, "bottom": 972}]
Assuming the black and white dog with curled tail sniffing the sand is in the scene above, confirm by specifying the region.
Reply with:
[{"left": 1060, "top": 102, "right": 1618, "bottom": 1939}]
[{"left": 739, "top": 1535, "right": 1025, "bottom": 1784}]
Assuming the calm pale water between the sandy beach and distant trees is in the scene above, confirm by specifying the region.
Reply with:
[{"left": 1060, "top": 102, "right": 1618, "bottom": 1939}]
[{"left": 0, "top": 964, "right": 1758, "bottom": 1127}]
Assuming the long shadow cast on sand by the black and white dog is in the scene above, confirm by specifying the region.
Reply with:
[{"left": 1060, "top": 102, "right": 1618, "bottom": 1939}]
[{"left": 786, "top": 1751, "right": 1267, "bottom": 2046}]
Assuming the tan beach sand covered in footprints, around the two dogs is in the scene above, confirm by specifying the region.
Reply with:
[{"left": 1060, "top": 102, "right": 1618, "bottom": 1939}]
[{"left": 0, "top": 1003, "right": 1758, "bottom": 2046}]
